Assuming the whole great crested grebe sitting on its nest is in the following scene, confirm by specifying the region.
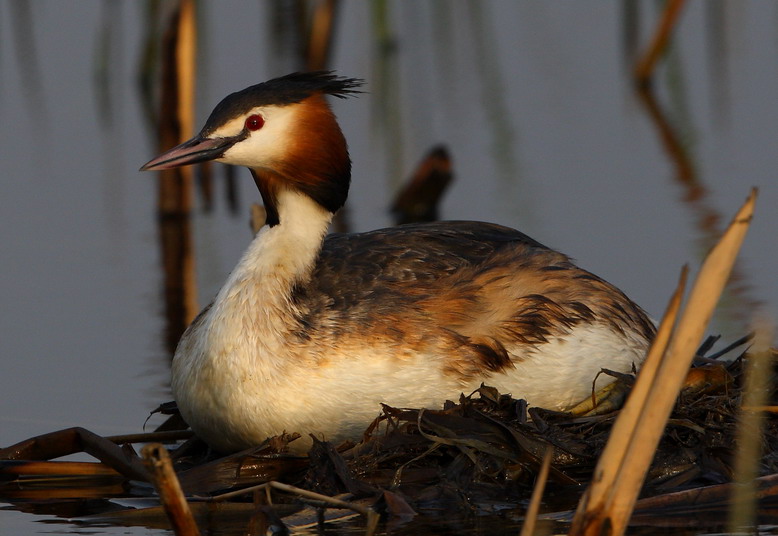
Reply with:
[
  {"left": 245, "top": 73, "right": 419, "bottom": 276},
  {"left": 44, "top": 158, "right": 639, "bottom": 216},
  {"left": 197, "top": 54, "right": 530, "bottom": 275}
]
[{"left": 141, "top": 72, "right": 654, "bottom": 452}]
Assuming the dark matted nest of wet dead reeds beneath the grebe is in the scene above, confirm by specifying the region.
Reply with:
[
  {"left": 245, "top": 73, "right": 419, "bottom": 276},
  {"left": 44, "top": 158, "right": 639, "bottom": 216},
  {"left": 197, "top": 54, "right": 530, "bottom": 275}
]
[{"left": 0, "top": 341, "right": 778, "bottom": 526}]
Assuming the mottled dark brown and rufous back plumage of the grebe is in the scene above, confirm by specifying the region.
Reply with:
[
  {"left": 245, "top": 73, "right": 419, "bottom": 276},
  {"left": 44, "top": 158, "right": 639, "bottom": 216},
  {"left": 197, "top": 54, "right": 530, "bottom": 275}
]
[{"left": 293, "top": 221, "right": 654, "bottom": 364}]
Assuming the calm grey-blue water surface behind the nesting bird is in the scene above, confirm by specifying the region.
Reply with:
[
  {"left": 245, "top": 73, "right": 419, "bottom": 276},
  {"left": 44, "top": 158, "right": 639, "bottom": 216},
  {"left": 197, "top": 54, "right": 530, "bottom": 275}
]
[{"left": 0, "top": 0, "right": 778, "bottom": 534}]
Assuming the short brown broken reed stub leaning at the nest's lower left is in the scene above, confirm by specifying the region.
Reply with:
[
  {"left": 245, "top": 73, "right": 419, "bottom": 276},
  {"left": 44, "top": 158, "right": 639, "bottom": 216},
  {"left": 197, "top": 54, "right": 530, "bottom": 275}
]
[{"left": 141, "top": 443, "right": 200, "bottom": 536}]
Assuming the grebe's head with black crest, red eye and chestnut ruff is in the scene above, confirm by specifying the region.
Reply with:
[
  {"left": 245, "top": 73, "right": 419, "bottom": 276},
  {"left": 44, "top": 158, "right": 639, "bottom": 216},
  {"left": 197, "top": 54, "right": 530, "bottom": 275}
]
[{"left": 141, "top": 71, "right": 363, "bottom": 226}]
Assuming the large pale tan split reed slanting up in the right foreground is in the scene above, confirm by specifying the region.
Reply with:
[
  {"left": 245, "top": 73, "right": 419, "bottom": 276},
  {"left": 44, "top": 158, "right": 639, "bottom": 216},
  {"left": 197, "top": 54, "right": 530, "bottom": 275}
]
[{"left": 570, "top": 190, "right": 756, "bottom": 535}]
